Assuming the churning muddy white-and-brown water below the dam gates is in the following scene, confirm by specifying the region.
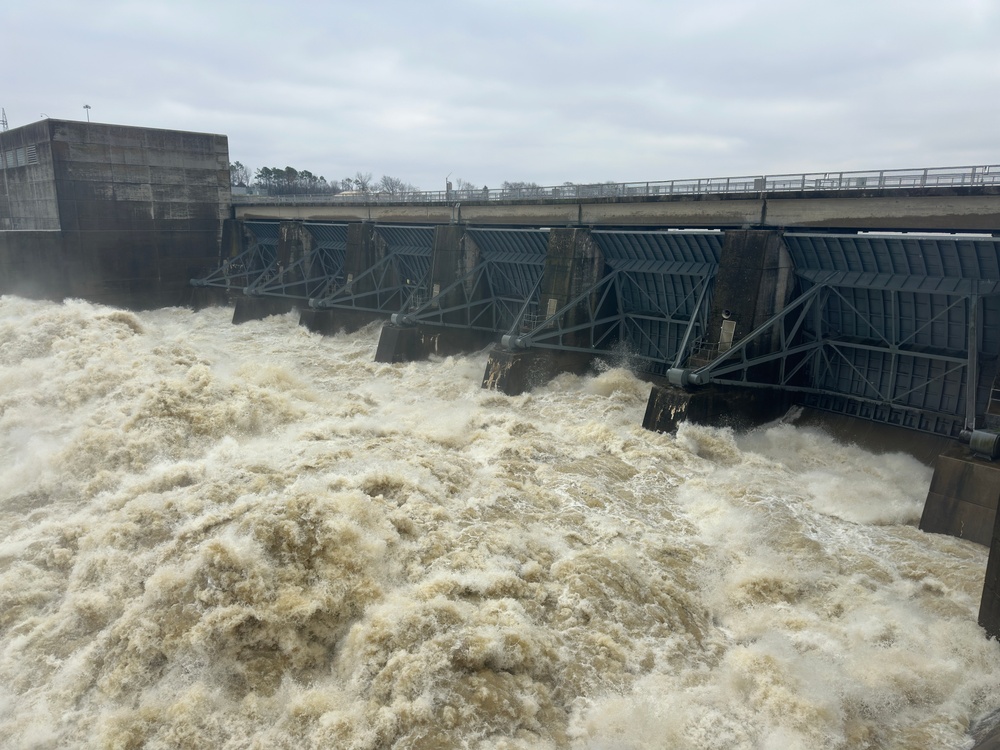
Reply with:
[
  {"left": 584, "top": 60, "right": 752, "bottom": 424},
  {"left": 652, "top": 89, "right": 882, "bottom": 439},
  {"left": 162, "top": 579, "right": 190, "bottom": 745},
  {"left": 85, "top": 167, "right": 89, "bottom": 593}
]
[{"left": 0, "top": 297, "right": 1000, "bottom": 750}]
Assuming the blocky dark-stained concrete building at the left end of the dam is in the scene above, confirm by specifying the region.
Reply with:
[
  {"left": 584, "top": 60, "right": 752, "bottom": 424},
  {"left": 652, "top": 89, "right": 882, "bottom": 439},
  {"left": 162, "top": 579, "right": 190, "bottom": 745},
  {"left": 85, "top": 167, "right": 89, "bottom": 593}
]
[{"left": 0, "top": 119, "right": 231, "bottom": 308}]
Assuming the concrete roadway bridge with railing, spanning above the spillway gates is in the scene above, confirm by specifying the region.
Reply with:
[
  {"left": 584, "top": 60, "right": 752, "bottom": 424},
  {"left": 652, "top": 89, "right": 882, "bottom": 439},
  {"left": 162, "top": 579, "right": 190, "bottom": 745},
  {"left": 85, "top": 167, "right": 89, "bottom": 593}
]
[{"left": 233, "top": 165, "right": 1000, "bottom": 233}]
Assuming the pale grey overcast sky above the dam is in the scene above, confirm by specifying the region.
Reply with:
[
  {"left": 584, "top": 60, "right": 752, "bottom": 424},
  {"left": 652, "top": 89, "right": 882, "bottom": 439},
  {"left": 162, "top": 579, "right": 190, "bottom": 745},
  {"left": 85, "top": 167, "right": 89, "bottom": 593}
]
[{"left": 0, "top": 0, "right": 1000, "bottom": 190}]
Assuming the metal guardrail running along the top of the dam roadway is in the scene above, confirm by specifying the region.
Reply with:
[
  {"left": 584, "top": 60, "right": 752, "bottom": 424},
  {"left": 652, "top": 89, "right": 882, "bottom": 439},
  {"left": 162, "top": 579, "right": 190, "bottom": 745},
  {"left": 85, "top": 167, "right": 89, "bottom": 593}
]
[{"left": 233, "top": 164, "right": 1000, "bottom": 205}]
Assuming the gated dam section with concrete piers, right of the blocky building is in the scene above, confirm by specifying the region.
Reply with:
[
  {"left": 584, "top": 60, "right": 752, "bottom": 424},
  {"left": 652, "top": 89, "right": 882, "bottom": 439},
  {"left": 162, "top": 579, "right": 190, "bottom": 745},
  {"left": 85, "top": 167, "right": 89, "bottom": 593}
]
[{"left": 194, "top": 170, "right": 1000, "bottom": 634}]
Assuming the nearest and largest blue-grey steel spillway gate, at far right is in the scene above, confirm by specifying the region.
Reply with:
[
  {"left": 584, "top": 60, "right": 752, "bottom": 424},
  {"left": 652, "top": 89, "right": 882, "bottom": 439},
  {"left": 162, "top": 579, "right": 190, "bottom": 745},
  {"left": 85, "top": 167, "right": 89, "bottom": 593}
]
[{"left": 689, "top": 234, "right": 1000, "bottom": 437}]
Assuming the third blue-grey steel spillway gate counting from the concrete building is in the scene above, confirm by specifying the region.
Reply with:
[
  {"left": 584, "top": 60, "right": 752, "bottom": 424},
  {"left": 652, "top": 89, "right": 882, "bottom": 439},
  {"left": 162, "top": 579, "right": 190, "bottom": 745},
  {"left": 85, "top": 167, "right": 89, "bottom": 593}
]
[{"left": 309, "top": 225, "right": 434, "bottom": 314}]
